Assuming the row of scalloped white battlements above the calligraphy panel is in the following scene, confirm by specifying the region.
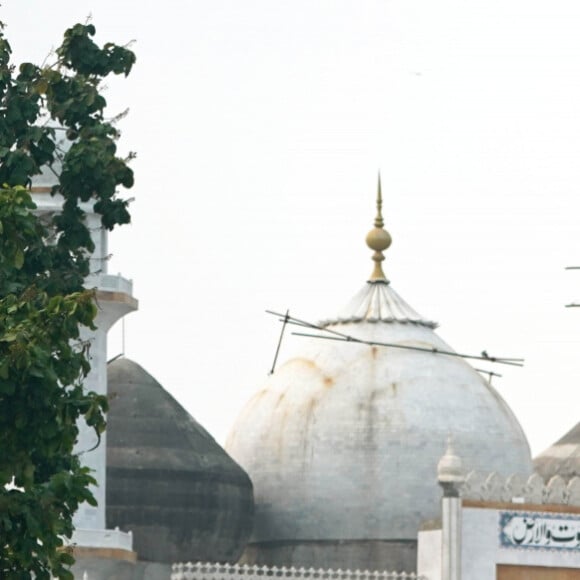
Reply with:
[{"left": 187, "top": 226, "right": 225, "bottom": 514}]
[{"left": 461, "top": 471, "right": 580, "bottom": 506}]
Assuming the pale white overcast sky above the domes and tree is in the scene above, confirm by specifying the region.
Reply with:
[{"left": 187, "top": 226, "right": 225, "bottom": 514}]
[{"left": 0, "top": 0, "right": 580, "bottom": 454}]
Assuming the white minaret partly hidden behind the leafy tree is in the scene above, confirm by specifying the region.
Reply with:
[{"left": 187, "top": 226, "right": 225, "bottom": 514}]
[{"left": 32, "top": 175, "right": 138, "bottom": 560}]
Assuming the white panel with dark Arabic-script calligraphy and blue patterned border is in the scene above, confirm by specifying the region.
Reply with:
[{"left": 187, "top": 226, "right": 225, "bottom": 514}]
[{"left": 500, "top": 512, "right": 580, "bottom": 551}]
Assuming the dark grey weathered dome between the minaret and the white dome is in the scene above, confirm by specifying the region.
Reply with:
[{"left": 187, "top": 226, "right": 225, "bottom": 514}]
[{"left": 107, "top": 358, "right": 254, "bottom": 563}]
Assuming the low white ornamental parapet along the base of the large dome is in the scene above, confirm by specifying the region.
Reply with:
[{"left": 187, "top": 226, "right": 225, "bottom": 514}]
[{"left": 171, "top": 562, "right": 427, "bottom": 580}]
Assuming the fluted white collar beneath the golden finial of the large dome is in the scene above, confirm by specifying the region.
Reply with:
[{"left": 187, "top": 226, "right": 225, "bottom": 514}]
[{"left": 320, "top": 280, "right": 437, "bottom": 329}]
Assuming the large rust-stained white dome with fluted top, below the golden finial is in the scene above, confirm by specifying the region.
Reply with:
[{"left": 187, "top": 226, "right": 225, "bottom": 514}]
[{"left": 226, "top": 186, "right": 532, "bottom": 570}]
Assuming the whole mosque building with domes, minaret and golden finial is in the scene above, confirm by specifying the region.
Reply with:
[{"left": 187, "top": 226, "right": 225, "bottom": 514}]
[{"left": 30, "top": 182, "right": 580, "bottom": 580}]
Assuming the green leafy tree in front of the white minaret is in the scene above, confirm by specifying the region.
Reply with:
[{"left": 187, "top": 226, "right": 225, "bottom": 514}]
[{"left": 0, "top": 24, "right": 135, "bottom": 580}]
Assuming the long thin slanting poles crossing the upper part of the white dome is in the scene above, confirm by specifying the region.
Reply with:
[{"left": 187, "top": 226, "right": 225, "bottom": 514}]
[{"left": 266, "top": 310, "right": 524, "bottom": 367}]
